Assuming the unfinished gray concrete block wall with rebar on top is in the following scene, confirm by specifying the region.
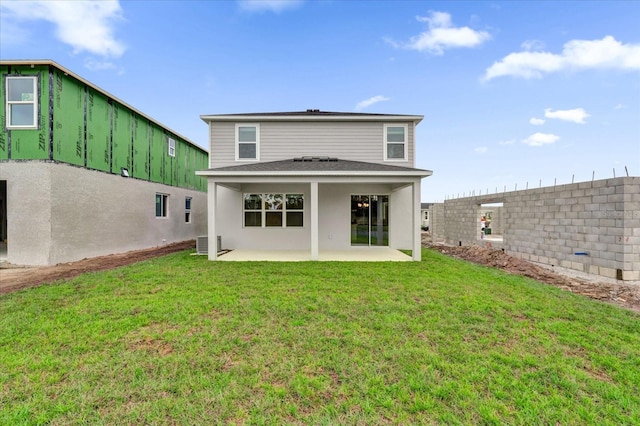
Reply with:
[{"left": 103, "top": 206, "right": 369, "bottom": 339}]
[{"left": 432, "top": 177, "right": 640, "bottom": 281}]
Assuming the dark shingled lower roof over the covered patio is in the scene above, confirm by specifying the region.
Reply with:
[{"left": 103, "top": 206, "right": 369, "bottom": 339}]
[{"left": 202, "top": 157, "right": 431, "bottom": 174}]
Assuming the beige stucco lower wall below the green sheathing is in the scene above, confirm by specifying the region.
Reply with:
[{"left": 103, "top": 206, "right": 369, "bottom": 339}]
[{"left": 0, "top": 162, "right": 207, "bottom": 265}]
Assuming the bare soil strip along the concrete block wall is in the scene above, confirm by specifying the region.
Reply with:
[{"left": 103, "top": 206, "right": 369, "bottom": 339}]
[{"left": 422, "top": 238, "right": 640, "bottom": 312}]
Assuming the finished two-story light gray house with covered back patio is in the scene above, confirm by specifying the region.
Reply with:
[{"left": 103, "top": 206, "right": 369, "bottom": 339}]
[{"left": 197, "top": 110, "right": 432, "bottom": 260}]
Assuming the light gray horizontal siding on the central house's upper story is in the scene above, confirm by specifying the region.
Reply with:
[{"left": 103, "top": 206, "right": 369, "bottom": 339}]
[{"left": 210, "top": 121, "right": 415, "bottom": 167}]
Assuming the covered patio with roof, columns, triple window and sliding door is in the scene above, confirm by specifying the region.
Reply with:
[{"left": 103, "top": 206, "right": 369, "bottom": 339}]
[{"left": 198, "top": 157, "right": 431, "bottom": 261}]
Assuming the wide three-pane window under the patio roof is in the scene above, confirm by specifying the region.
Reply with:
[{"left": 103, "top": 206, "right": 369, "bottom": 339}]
[{"left": 243, "top": 194, "right": 304, "bottom": 228}]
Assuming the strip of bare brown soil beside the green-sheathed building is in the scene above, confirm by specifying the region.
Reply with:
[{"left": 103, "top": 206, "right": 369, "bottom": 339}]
[{"left": 0, "top": 240, "right": 196, "bottom": 293}]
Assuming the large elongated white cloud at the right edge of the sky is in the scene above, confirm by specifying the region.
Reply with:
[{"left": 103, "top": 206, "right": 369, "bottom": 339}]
[{"left": 484, "top": 36, "right": 640, "bottom": 80}]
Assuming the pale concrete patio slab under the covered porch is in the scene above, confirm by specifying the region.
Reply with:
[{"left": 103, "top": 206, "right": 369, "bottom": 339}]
[{"left": 218, "top": 247, "right": 412, "bottom": 262}]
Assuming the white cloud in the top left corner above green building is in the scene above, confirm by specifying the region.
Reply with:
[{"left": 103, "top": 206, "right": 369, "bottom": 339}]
[{"left": 0, "top": 0, "right": 126, "bottom": 57}]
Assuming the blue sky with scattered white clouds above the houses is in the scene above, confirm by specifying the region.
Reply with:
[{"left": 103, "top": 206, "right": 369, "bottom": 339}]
[{"left": 0, "top": 0, "right": 640, "bottom": 201}]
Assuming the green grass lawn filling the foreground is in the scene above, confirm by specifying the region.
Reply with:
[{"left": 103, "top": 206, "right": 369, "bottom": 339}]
[{"left": 0, "top": 250, "right": 640, "bottom": 425}]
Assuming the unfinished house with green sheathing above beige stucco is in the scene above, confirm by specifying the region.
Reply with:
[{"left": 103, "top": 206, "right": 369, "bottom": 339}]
[{"left": 0, "top": 60, "right": 208, "bottom": 265}]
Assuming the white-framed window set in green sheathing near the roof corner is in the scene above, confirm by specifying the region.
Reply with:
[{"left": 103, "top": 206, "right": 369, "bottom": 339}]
[{"left": 6, "top": 76, "right": 38, "bottom": 129}]
